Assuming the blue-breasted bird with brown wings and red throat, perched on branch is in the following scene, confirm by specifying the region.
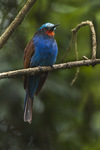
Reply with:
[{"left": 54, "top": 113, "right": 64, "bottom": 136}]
[{"left": 23, "top": 23, "right": 59, "bottom": 123}]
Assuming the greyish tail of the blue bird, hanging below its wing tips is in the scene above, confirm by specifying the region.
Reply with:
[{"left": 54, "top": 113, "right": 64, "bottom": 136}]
[{"left": 24, "top": 91, "right": 33, "bottom": 123}]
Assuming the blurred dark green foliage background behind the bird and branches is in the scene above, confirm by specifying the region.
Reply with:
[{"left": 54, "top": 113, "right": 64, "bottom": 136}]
[{"left": 0, "top": 0, "right": 100, "bottom": 150}]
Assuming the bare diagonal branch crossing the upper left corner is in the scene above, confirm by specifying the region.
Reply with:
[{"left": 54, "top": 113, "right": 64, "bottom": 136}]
[{"left": 0, "top": 0, "right": 36, "bottom": 48}]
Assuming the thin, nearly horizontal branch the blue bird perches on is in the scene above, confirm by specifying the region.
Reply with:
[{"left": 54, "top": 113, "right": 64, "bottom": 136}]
[{"left": 0, "top": 59, "right": 100, "bottom": 79}]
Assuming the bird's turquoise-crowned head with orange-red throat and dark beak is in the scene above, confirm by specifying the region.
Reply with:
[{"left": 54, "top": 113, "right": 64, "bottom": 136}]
[{"left": 38, "top": 23, "right": 59, "bottom": 36}]
